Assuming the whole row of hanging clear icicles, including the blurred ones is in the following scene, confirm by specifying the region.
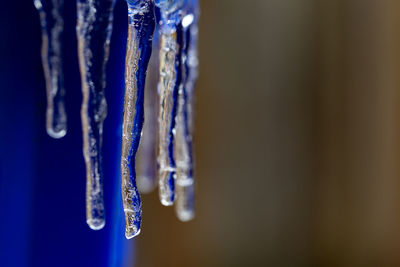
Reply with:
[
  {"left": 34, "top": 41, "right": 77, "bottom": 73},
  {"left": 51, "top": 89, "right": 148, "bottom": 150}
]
[{"left": 34, "top": 0, "right": 199, "bottom": 238}]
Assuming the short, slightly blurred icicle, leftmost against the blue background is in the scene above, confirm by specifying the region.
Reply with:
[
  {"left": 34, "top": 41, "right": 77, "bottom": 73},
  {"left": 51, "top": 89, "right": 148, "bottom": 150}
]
[{"left": 34, "top": 0, "right": 67, "bottom": 138}]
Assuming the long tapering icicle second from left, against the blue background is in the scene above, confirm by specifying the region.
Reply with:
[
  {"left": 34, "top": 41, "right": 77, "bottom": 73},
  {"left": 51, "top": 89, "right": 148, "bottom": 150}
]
[{"left": 77, "top": 0, "right": 115, "bottom": 230}]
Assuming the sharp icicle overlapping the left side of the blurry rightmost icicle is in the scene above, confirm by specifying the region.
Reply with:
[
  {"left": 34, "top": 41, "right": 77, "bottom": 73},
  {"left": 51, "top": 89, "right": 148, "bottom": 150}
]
[{"left": 155, "top": 0, "right": 184, "bottom": 206}]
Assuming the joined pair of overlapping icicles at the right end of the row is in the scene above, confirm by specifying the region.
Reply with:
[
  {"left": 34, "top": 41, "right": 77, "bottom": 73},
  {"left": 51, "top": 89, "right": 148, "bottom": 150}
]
[{"left": 156, "top": 0, "right": 199, "bottom": 221}]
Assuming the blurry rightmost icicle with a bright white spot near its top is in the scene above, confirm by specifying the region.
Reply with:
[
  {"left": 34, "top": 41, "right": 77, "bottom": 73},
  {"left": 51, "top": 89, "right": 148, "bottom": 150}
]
[{"left": 175, "top": 0, "right": 199, "bottom": 221}]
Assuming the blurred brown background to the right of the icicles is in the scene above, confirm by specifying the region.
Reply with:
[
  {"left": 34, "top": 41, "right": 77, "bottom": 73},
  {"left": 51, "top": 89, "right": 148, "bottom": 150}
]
[{"left": 135, "top": 0, "right": 400, "bottom": 267}]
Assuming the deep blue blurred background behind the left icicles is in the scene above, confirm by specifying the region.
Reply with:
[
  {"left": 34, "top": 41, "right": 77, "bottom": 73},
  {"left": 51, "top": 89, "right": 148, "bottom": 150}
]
[{"left": 0, "top": 0, "right": 134, "bottom": 266}]
